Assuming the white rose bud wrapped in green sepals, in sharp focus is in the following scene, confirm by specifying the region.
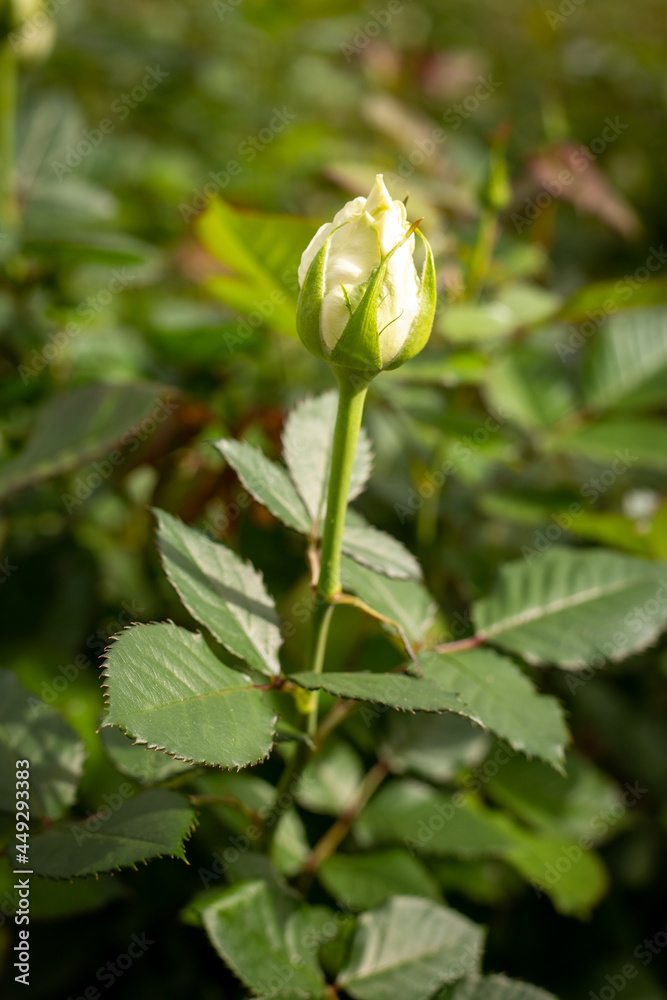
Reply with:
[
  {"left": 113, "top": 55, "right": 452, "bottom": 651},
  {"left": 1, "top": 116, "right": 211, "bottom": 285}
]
[{"left": 297, "top": 174, "right": 436, "bottom": 375}]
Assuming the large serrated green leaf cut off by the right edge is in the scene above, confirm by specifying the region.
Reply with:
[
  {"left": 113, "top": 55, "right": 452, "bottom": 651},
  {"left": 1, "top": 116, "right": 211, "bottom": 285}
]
[{"left": 475, "top": 549, "right": 667, "bottom": 669}]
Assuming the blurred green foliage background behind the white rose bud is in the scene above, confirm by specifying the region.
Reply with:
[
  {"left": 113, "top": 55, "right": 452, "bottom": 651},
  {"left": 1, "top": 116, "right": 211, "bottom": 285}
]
[{"left": 0, "top": 0, "right": 667, "bottom": 1000}]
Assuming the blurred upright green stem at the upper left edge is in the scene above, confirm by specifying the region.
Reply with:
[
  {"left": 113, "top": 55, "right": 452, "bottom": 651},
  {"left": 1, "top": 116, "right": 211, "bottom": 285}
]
[{"left": 0, "top": 0, "right": 17, "bottom": 239}]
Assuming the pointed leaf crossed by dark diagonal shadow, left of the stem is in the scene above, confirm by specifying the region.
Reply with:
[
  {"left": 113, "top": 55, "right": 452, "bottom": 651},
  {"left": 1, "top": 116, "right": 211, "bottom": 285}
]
[{"left": 155, "top": 510, "right": 282, "bottom": 675}]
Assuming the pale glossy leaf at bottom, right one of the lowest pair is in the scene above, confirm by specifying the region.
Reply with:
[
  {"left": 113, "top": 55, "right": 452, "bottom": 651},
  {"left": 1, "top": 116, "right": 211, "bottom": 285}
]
[{"left": 339, "top": 896, "right": 483, "bottom": 1000}]
